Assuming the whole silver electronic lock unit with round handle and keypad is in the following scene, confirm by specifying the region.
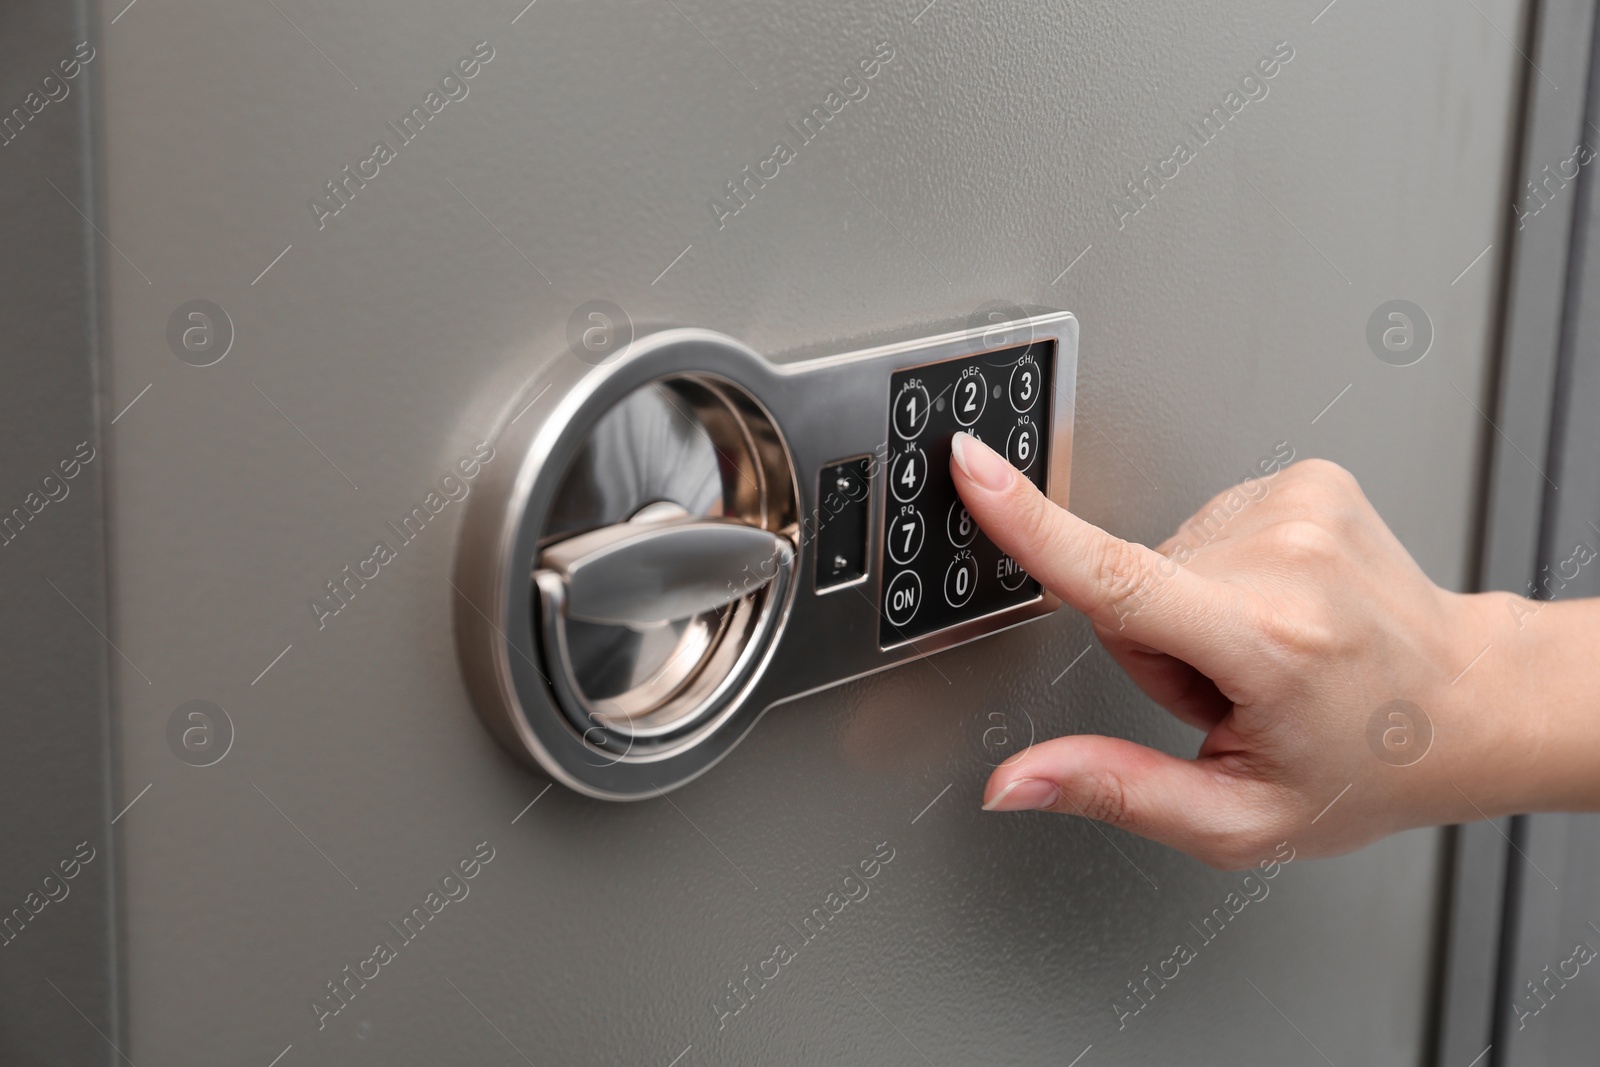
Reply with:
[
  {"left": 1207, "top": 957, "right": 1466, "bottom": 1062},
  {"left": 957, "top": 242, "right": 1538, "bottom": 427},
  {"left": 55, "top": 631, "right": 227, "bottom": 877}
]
[{"left": 454, "top": 312, "right": 1077, "bottom": 800}]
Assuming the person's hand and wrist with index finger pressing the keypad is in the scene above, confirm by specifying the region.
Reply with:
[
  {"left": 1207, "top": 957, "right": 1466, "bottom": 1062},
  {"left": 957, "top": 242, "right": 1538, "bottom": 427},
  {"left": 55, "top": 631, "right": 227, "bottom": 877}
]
[{"left": 950, "top": 434, "right": 1600, "bottom": 870}]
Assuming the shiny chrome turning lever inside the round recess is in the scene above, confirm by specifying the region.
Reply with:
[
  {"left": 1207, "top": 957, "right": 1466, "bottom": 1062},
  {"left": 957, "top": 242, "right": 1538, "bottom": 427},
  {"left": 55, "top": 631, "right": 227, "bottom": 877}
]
[{"left": 539, "top": 517, "right": 795, "bottom": 627}]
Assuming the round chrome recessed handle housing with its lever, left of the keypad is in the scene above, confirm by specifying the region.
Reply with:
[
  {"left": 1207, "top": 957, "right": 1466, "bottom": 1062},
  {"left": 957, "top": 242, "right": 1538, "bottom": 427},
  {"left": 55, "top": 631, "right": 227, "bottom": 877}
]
[{"left": 456, "top": 330, "right": 798, "bottom": 800}]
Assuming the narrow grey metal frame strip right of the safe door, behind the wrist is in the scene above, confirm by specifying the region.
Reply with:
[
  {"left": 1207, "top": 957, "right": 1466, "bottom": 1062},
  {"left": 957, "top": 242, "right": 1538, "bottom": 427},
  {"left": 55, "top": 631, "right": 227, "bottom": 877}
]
[{"left": 1435, "top": 0, "right": 1595, "bottom": 1067}]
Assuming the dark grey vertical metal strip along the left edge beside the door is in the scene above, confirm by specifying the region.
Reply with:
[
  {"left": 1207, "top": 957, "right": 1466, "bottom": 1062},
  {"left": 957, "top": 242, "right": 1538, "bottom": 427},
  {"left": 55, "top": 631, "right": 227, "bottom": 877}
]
[{"left": 0, "top": 3, "right": 118, "bottom": 1067}]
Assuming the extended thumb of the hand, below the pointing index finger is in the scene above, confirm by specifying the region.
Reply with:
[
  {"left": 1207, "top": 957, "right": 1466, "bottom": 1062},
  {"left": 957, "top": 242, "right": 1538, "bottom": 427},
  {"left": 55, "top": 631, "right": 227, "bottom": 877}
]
[{"left": 984, "top": 736, "right": 1275, "bottom": 870}]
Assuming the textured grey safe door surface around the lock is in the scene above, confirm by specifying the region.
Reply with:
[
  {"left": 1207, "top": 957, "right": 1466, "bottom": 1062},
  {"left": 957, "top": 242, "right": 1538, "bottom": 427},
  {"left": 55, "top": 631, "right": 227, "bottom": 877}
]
[{"left": 98, "top": 0, "right": 1522, "bottom": 1067}]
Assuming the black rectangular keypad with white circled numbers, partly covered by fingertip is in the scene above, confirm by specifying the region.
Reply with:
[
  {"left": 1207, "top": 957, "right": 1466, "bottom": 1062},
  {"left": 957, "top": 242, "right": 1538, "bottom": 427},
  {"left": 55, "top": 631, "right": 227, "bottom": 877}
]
[{"left": 878, "top": 341, "right": 1056, "bottom": 648}]
